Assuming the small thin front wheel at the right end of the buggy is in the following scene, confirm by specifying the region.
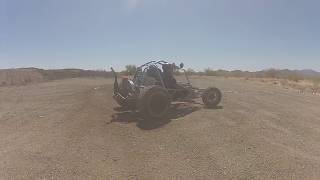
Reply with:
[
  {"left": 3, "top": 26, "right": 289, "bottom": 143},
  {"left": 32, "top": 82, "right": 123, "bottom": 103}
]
[{"left": 201, "top": 87, "right": 222, "bottom": 108}]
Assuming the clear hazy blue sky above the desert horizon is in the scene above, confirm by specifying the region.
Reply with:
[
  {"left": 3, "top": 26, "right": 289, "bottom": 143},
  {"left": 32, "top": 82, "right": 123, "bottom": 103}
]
[{"left": 0, "top": 0, "right": 320, "bottom": 71}]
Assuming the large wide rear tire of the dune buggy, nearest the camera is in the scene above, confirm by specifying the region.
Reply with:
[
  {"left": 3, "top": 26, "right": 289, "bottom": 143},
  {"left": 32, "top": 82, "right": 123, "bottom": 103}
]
[{"left": 138, "top": 86, "right": 171, "bottom": 120}]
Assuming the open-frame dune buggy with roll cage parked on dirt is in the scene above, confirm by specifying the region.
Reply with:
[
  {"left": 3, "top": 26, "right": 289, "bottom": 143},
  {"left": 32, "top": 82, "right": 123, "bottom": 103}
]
[{"left": 111, "top": 61, "right": 222, "bottom": 119}]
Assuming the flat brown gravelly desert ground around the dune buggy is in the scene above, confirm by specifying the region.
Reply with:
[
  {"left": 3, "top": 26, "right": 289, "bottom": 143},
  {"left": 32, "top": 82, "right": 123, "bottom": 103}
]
[{"left": 0, "top": 77, "right": 320, "bottom": 180}]
